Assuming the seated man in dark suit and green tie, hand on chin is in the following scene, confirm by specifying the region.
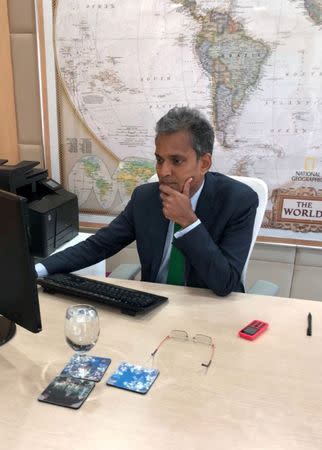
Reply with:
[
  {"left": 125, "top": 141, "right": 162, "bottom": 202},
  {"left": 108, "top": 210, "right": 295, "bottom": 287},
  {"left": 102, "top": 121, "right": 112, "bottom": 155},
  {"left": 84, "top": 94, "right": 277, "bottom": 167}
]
[{"left": 36, "top": 107, "right": 258, "bottom": 296}]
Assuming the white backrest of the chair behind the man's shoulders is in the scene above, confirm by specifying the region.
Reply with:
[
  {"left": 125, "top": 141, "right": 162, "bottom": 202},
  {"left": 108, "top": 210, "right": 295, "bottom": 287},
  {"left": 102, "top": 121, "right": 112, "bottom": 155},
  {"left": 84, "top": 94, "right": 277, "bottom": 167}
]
[{"left": 148, "top": 173, "right": 268, "bottom": 284}]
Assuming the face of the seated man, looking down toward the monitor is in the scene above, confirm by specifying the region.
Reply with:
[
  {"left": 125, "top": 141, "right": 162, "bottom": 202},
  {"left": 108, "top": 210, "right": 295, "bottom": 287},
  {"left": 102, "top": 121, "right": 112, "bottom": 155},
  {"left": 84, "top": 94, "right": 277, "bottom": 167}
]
[{"left": 155, "top": 131, "right": 211, "bottom": 196}]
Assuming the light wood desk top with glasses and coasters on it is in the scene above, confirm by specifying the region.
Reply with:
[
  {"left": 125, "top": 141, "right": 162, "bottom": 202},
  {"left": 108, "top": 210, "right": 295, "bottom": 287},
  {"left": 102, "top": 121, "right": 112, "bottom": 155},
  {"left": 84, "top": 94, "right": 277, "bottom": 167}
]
[{"left": 0, "top": 280, "right": 322, "bottom": 450}]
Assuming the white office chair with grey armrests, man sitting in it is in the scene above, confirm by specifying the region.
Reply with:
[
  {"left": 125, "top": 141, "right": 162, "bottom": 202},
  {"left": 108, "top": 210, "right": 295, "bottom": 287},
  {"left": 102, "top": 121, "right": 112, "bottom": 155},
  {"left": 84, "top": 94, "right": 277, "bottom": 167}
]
[{"left": 110, "top": 174, "right": 279, "bottom": 295}]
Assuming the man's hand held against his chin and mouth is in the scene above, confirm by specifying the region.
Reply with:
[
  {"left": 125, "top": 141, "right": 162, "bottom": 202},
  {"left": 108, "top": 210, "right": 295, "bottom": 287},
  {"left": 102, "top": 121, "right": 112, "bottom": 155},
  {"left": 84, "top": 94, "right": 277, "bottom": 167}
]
[{"left": 160, "top": 178, "right": 198, "bottom": 228}]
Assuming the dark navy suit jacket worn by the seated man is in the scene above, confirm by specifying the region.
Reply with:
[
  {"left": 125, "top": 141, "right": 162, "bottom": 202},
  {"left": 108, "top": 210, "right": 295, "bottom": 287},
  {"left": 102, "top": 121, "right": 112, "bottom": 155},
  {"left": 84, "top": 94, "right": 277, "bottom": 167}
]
[{"left": 42, "top": 172, "right": 258, "bottom": 295}]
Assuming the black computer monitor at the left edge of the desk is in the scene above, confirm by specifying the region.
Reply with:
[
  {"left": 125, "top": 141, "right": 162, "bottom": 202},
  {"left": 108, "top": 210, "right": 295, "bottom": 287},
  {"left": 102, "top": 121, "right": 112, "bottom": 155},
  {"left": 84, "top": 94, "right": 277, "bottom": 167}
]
[{"left": 0, "top": 190, "right": 41, "bottom": 345}]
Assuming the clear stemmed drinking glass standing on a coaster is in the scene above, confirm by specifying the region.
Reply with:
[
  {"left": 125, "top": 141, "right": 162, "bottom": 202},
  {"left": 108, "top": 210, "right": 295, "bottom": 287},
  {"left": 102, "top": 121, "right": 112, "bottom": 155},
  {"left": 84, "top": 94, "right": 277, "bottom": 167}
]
[{"left": 65, "top": 305, "right": 100, "bottom": 377}]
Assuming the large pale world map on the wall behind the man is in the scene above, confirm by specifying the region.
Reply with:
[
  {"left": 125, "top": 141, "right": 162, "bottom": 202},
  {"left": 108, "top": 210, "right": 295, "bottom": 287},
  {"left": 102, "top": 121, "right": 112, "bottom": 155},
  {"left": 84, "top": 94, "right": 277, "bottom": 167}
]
[{"left": 54, "top": 0, "right": 322, "bottom": 243}]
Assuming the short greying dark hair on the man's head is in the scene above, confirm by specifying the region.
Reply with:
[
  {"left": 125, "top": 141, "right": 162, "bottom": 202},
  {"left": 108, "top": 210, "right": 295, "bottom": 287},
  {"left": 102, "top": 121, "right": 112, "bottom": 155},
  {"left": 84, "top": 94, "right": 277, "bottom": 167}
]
[{"left": 155, "top": 106, "right": 215, "bottom": 159}]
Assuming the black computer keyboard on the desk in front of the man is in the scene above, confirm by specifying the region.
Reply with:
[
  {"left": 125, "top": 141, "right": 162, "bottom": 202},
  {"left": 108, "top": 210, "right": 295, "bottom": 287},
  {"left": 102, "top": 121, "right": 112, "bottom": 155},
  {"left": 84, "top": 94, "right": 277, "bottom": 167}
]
[{"left": 37, "top": 273, "right": 168, "bottom": 316}]
